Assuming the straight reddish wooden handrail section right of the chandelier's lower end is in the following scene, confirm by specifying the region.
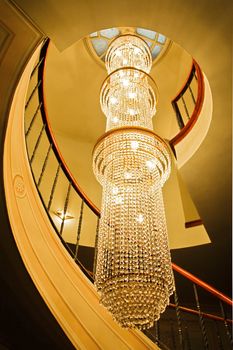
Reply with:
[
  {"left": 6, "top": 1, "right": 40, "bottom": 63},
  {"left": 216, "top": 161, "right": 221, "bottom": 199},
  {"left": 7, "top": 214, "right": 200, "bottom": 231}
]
[{"left": 172, "top": 263, "right": 233, "bottom": 306}]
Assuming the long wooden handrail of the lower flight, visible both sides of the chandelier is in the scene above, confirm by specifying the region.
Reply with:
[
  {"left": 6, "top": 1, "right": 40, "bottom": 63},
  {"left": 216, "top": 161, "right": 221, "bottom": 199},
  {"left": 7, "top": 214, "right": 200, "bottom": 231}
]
[{"left": 38, "top": 41, "right": 233, "bottom": 305}]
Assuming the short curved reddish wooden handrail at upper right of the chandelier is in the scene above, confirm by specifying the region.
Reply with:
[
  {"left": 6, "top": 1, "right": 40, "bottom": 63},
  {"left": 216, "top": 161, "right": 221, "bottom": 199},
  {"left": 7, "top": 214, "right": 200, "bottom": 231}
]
[{"left": 169, "top": 60, "right": 205, "bottom": 147}]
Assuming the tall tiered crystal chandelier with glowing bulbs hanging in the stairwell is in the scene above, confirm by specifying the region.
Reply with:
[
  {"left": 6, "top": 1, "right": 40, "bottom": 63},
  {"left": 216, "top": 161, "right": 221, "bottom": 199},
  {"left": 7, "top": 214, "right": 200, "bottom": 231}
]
[{"left": 93, "top": 35, "right": 174, "bottom": 329}]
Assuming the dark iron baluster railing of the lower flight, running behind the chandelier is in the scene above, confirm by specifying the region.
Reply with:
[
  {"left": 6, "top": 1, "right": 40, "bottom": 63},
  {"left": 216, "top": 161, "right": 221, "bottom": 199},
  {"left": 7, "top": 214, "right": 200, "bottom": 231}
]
[{"left": 25, "top": 40, "right": 232, "bottom": 350}]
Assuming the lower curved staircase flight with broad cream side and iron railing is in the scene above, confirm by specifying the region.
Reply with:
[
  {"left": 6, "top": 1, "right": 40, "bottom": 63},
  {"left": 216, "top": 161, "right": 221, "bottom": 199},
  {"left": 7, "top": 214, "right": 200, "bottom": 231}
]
[{"left": 4, "top": 37, "right": 232, "bottom": 349}]
